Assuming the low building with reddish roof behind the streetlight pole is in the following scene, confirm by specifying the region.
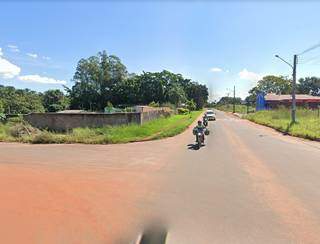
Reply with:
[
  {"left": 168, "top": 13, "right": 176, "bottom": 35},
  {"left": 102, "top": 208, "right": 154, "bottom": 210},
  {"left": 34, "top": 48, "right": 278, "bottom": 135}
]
[{"left": 264, "top": 93, "right": 320, "bottom": 109}]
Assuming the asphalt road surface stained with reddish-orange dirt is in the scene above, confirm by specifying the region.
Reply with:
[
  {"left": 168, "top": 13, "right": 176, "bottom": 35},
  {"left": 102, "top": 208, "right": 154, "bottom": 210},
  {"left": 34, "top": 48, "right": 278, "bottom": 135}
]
[{"left": 0, "top": 112, "right": 320, "bottom": 244}]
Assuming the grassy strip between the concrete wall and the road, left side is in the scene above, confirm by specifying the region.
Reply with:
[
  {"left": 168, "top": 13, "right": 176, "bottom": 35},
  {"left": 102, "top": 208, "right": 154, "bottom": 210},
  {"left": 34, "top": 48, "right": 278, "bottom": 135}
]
[{"left": 0, "top": 111, "right": 202, "bottom": 144}]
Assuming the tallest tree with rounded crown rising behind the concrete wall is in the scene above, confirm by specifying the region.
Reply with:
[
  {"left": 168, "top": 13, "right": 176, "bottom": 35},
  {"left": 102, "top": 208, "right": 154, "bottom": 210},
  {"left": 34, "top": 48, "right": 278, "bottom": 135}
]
[{"left": 67, "top": 51, "right": 128, "bottom": 111}]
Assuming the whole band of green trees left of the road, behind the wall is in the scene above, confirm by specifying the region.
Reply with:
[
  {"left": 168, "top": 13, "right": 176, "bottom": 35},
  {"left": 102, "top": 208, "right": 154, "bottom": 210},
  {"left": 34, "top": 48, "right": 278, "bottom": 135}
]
[{"left": 0, "top": 51, "right": 209, "bottom": 114}]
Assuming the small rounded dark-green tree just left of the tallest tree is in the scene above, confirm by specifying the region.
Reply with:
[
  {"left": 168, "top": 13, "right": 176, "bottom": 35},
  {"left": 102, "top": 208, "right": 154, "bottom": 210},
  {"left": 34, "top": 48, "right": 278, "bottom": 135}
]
[{"left": 43, "top": 89, "right": 69, "bottom": 112}]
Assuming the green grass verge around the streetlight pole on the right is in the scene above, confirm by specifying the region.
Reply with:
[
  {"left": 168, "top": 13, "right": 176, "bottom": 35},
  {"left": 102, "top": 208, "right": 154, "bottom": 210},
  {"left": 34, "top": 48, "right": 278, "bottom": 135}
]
[{"left": 244, "top": 108, "right": 320, "bottom": 140}]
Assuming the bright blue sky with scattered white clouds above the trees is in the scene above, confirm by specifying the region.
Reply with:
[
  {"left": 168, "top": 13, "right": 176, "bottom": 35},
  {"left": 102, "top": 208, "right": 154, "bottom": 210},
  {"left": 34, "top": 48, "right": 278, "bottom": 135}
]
[{"left": 0, "top": 0, "right": 320, "bottom": 98}]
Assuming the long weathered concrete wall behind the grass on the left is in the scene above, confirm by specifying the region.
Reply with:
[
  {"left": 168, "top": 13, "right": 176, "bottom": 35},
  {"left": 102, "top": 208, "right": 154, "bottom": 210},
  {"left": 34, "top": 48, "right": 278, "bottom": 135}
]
[{"left": 23, "top": 108, "right": 170, "bottom": 131}]
